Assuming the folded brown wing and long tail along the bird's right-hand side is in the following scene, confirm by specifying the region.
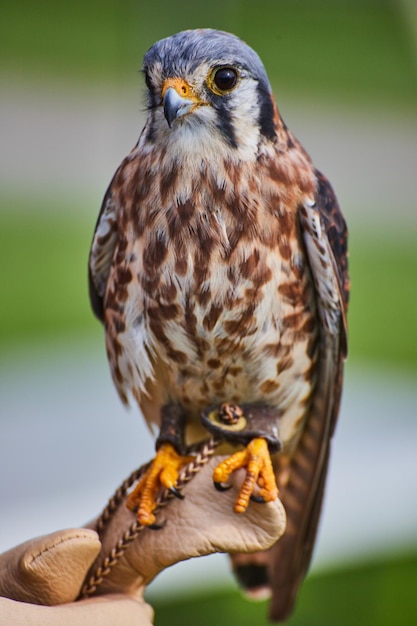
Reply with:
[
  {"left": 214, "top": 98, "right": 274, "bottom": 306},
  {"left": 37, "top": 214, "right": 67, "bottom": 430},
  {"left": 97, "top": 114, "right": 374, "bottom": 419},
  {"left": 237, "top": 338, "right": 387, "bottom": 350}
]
[{"left": 270, "top": 172, "right": 349, "bottom": 621}]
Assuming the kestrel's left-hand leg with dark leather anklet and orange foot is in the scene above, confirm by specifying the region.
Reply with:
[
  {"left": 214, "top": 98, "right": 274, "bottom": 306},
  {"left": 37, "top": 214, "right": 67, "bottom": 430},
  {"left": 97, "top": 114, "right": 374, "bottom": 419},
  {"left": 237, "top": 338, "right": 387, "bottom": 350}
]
[{"left": 126, "top": 405, "right": 194, "bottom": 526}]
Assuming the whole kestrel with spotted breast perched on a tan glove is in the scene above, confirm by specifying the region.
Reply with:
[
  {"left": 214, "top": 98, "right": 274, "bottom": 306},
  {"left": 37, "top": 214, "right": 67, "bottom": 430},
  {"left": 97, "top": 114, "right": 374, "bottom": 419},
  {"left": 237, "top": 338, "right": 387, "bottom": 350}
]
[{"left": 89, "top": 29, "right": 349, "bottom": 621}]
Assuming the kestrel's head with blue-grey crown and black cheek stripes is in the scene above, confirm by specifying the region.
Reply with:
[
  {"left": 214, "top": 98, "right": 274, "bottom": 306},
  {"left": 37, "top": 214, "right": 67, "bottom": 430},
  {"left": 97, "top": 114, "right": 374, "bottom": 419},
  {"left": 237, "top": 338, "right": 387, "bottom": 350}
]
[{"left": 143, "top": 29, "right": 277, "bottom": 158}]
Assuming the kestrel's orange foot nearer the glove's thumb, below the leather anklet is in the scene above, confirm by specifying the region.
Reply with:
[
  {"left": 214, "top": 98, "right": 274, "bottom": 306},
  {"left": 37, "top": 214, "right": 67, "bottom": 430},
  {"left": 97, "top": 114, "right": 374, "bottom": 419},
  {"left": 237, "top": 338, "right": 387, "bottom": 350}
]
[{"left": 126, "top": 443, "right": 194, "bottom": 526}]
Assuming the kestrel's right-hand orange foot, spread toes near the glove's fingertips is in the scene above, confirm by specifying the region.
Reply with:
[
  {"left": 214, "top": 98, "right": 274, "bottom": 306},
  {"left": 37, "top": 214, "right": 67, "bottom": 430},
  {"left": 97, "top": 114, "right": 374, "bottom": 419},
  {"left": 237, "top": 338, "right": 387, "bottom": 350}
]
[{"left": 213, "top": 438, "right": 278, "bottom": 513}]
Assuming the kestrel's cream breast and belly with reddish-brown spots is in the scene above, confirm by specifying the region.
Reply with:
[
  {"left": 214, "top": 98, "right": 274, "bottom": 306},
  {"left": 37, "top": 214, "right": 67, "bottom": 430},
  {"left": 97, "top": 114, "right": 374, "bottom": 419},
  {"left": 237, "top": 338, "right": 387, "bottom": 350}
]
[{"left": 99, "top": 132, "right": 318, "bottom": 444}]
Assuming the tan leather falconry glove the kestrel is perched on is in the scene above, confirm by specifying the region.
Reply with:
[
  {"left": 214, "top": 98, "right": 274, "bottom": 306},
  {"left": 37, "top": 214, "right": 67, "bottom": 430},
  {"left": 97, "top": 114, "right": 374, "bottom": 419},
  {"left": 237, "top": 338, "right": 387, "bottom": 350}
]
[{"left": 0, "top": 457, "right": 285, "bottom": 626}]
